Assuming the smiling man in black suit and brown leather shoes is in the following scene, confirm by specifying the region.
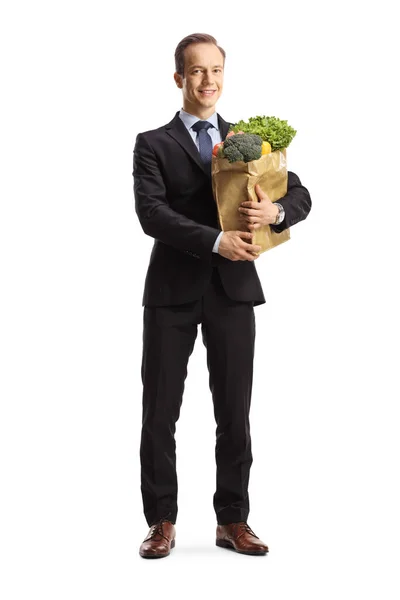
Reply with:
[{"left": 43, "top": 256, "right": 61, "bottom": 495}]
[{"left": 133, "top": 34, "right": 311, "bottom": 558}]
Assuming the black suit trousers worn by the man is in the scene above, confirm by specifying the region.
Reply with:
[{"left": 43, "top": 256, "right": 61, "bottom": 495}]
[{"left": 140, "top": 267, "right": 255, "bottom": 526}]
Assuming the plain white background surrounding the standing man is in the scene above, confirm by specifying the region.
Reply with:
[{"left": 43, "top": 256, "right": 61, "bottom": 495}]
[{"left": 0, "top": 0, "right": 400, "bottom": 600}]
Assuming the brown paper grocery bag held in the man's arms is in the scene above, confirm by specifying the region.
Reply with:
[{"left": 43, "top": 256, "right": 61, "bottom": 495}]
[{"left": 212, "top": 148, "right": 290, "bottom": 254}]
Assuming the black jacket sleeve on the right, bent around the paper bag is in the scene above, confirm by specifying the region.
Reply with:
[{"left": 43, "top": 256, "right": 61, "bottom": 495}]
[{"left": 270, "top": 171, "right": 311, "bottom": 233}]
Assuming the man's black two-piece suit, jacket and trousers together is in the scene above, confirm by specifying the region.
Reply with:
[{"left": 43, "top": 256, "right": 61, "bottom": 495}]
[{"left": 133, "top": 112, "right": 311, "bottom": 525}]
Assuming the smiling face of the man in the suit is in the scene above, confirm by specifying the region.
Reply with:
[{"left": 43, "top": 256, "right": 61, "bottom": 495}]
[{"left": 174, "top": 43, "right": 224, "bottom": 119}]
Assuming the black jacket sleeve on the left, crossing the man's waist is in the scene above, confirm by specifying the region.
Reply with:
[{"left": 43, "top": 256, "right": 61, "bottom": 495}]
[{"left": 132, "top": 133, "right": 220, "bottom": 261}]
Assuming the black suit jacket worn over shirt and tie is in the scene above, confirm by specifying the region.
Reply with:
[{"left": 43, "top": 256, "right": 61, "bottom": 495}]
[{"left": 132, "top": 111, "right": 311, "bottom": 306}]
